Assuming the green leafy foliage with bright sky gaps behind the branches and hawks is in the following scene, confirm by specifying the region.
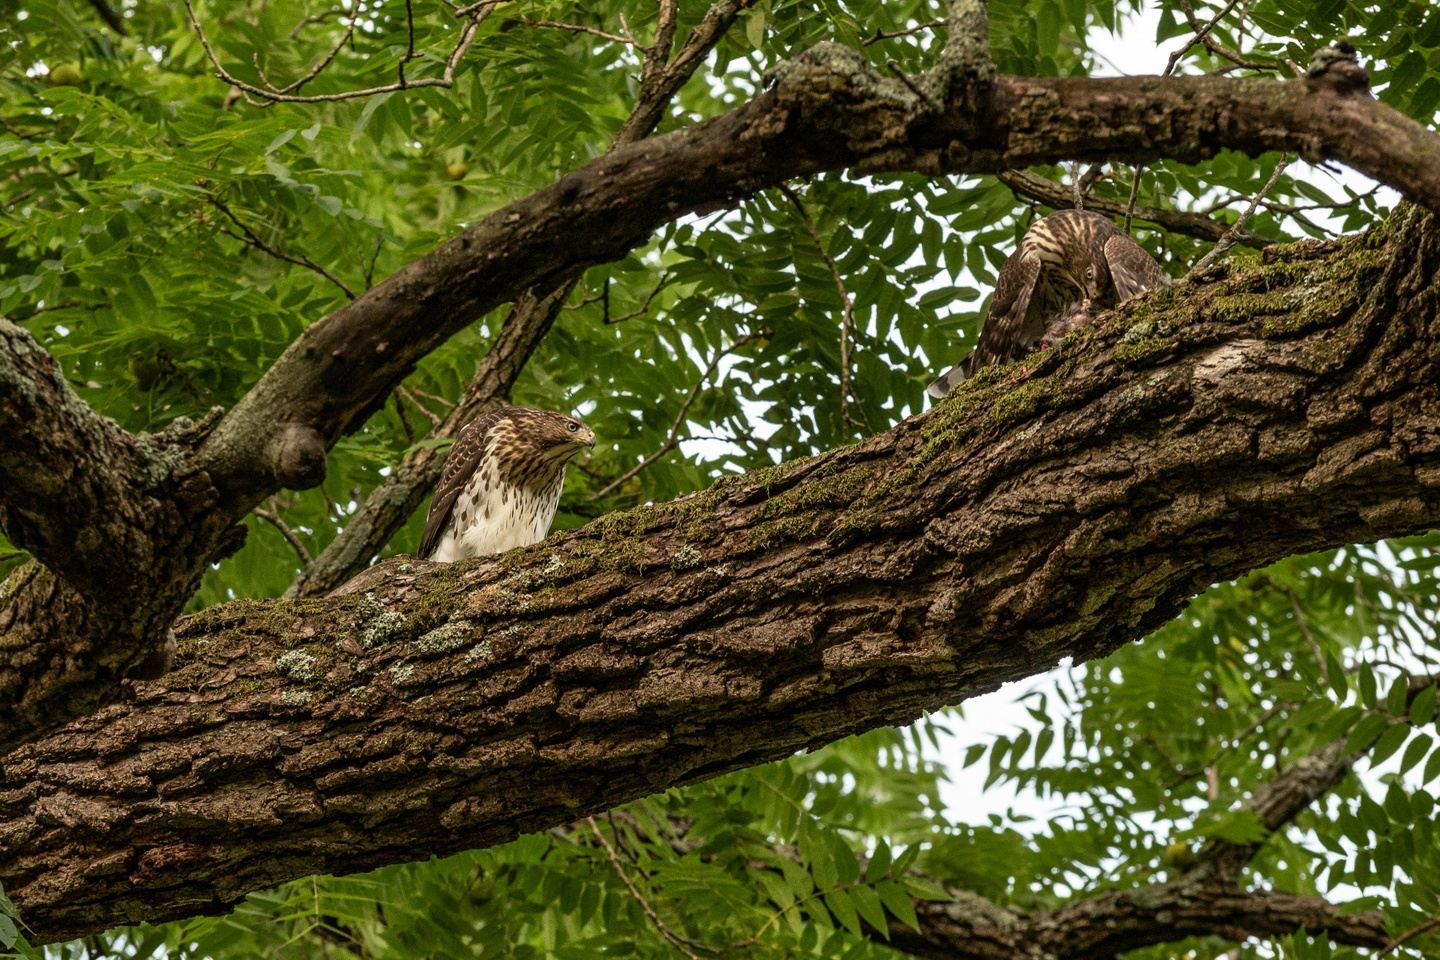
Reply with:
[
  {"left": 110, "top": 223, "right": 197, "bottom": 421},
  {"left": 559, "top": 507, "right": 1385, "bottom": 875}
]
[{"left": 0, "top": 0, "right": 1440, "bottom": 959}]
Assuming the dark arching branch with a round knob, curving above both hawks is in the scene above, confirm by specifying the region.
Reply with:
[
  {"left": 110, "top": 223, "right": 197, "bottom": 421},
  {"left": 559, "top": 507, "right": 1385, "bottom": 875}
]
[{"left": 191, "top": 46, "right": 1440, "bottom": 510}]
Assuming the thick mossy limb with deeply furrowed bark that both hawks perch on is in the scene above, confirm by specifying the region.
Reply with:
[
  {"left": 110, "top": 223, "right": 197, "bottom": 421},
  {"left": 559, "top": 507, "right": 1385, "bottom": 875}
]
[{"left": 0, "top": 210, "right": 1440, "bottom": 940}]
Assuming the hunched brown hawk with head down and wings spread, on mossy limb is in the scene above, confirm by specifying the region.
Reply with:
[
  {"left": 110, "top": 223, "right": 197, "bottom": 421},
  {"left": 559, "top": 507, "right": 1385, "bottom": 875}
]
[{"left": 926, "top": 210, "right": 1166, "bottom": 397}]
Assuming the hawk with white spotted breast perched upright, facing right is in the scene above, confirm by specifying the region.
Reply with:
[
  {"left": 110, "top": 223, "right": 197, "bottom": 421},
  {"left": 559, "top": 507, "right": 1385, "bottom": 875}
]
[{"left": 420, "top": 407, "right": 595, "bottom": 563}]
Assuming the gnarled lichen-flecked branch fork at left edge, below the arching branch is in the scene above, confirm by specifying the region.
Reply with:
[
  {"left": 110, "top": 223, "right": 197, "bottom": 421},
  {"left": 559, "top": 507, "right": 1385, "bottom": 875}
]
[{"left": 0, "top": 318, "right": 229, "bottom": 753}]
